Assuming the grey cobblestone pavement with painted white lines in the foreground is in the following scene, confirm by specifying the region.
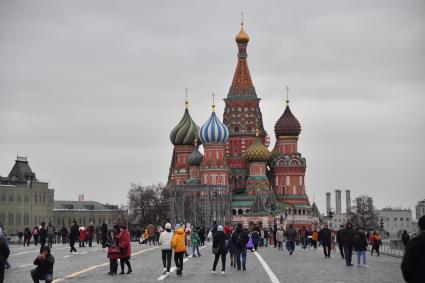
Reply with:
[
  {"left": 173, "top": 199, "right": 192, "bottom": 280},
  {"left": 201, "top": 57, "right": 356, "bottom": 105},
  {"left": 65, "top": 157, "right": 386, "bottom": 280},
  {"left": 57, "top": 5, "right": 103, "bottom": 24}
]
[{"left": 5, "top": 244, "right": 404, "bottom": 283}]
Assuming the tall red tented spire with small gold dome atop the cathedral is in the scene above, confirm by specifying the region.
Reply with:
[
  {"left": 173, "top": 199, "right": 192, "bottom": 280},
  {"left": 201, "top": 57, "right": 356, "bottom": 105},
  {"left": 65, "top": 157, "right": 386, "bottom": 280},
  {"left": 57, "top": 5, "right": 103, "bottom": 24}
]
[{"left": 227, "top": 24, "right": 257, "bottom": 99}]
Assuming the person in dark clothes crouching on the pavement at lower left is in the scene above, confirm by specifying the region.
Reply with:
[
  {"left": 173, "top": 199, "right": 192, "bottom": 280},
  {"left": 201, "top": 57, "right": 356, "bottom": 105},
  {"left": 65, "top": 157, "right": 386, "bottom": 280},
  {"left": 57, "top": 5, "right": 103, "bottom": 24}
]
[{"left": 31, "top": 246, "right": 55, "bottom": 283}]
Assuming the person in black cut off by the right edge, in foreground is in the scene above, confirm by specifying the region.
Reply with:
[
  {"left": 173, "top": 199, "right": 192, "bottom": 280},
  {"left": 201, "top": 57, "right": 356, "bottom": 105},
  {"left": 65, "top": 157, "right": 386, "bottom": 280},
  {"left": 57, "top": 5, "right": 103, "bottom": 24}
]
[{"left": 401, "top": 215, "right": 425, "bottom": 283}]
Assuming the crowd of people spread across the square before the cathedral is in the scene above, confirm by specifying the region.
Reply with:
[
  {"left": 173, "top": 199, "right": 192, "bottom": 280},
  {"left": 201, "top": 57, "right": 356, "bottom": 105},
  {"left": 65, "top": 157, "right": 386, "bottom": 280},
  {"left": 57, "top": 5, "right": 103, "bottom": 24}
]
[{"left": 0, "top": 216, "right": 425, "bottom": 283}]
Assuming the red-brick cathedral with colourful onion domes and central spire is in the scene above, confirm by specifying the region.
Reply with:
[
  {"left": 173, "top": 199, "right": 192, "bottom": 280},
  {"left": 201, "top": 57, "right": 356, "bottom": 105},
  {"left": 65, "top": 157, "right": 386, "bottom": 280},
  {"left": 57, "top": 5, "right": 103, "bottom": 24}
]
[{"left": 169, "top": 23, "right": 319, "bottom": 228}]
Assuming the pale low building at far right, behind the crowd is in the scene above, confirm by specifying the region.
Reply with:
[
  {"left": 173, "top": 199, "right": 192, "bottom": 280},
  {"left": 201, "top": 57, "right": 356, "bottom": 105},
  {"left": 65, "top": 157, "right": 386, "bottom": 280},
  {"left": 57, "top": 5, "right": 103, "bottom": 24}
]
[{"left": 377, "top": 207, "right": 410, "bottom": 236}]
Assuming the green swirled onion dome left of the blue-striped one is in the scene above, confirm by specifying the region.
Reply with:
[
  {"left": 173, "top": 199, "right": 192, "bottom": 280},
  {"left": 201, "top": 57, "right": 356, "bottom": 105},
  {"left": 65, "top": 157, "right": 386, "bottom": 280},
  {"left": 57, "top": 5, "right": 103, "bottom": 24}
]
[{"left": 170, "top": 106, "right": 199, "bottom": 145}]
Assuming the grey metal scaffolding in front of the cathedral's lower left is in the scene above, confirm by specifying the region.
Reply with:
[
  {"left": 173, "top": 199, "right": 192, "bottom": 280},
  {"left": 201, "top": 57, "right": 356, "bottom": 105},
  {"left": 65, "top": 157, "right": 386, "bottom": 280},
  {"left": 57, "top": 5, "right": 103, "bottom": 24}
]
[{"left": 170, "top": 185, "right": 232, "bottom": 227}]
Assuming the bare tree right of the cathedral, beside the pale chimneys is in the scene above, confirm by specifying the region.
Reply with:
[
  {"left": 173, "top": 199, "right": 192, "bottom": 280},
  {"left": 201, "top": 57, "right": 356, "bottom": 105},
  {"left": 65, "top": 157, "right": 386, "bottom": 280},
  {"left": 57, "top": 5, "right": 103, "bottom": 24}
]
[{"left": 348, "top": 195, "right": 378, "bottom": 230}]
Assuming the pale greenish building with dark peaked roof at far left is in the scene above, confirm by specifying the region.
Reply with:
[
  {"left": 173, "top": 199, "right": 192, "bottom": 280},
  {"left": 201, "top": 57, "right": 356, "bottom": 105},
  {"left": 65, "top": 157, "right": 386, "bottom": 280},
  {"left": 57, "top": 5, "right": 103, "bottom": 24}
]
[{"left": 0, "top": 156, "right": 54, "bottom": 235}]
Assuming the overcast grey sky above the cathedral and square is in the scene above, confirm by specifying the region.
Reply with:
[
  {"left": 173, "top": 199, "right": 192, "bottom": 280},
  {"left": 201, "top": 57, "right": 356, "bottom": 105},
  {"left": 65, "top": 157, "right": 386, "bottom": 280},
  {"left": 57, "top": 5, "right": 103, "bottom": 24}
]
[{"left": 0, "top": 0, "right": 425, "bottom": 217}]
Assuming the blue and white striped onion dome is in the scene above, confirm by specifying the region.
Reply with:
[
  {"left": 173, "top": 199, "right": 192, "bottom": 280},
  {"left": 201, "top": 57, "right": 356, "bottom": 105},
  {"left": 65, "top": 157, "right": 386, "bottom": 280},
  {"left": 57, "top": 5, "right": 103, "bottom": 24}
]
[{"left": 199, "top": 110, "right": 229, "bottom": 144}]
